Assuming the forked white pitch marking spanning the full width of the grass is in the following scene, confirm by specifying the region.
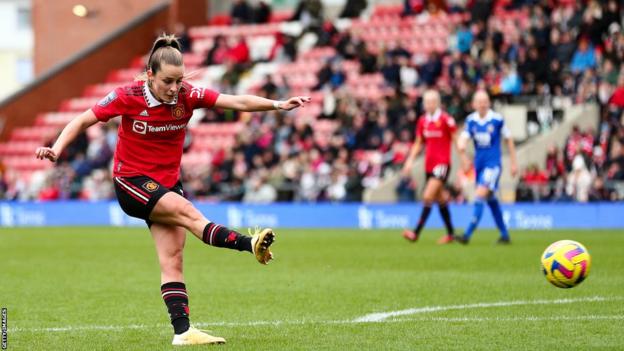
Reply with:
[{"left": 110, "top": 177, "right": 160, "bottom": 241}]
[{"left": 8, "top": 296, "right": 624, "bottom": 333}]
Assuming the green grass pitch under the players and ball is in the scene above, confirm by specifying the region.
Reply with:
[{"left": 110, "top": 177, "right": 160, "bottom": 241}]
[{"left": 0, "top": 227, "right": 624, "bottom": 350}]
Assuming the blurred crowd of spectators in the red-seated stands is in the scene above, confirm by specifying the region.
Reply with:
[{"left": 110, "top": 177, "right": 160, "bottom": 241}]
[{"left": 2, "top": 0, "right": 624, "bottom": 203}]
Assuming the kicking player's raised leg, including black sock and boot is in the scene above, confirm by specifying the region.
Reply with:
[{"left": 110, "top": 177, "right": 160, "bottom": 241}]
[{"left": 150, "top": 192, "right": 274, "bottom": 264}]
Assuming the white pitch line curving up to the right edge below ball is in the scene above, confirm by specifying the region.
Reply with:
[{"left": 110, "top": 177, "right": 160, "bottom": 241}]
[{"left": 353, "top": 296, "right": 621, "bottom": 323}]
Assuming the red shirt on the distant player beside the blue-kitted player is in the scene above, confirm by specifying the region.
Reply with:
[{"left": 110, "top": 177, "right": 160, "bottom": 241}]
[{"left": 416, "top": 110, "right": 457, "bottom": 173}]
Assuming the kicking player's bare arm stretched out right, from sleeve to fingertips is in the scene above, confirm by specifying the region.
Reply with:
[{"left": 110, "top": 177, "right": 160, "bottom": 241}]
[{"left": 215, "top": 94, "right": 310, "bottom": 112}]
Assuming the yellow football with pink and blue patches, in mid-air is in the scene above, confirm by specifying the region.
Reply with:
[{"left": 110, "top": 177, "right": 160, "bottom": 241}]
[{"left": 541, "top": 240, "right": 591, "bottom": 289}]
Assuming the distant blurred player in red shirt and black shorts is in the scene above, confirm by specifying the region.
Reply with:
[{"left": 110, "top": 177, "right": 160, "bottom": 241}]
[{"left": 402, "top": 90, "right": 456, "bottom": 244}]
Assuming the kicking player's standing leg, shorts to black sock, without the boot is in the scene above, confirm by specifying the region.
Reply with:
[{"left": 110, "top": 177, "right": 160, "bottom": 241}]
[{"left": 150, "top": 223, "right": 190, "bottom": 334}]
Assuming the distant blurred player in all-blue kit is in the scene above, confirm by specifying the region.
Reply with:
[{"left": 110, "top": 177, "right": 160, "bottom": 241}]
[{"left": 456, "top": 91, "right": 517, "bottom": 244}]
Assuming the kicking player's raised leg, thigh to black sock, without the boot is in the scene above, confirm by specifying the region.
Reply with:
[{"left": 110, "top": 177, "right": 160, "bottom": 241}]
[{"left": 150, "top": 192, "right": 253, "bottom": 252}]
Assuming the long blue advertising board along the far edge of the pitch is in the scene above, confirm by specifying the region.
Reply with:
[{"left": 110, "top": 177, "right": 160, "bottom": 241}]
[{"left": 0, "top": 201, "right": 624, "bottom": 230}]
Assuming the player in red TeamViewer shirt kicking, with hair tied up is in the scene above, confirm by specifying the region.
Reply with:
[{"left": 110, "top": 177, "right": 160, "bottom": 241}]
[{"left": 36, "top": 35, "right": 310, "bottom": 345}]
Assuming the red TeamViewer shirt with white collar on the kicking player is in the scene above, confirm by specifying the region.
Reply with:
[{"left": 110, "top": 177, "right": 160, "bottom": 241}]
[{"left": 92, "top": 81, "right": 219, "bottom": 187}]
